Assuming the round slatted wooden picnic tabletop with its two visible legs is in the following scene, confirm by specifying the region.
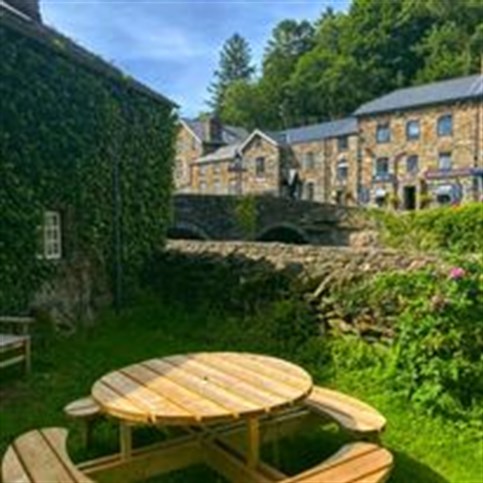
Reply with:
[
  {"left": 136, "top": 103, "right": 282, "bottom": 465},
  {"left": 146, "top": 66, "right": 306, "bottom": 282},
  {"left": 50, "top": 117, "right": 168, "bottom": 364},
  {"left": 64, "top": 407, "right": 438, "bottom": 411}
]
[{"left": 92, "top": 352, "right": 312, "bottom": 466}]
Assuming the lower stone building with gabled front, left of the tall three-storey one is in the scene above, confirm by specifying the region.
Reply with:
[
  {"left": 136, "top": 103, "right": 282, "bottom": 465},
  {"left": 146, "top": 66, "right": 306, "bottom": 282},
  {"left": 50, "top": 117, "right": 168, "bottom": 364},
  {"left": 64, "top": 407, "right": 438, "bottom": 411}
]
[{"left": 190, "top": 118, "right": 357, "bottom": 204}]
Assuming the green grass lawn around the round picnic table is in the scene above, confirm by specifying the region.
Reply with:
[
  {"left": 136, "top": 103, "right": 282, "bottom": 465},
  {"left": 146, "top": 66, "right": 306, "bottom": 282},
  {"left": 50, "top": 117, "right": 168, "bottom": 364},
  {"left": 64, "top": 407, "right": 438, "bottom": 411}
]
[{"left": 0, "top": 299, "right": 483, "bottom": 483}]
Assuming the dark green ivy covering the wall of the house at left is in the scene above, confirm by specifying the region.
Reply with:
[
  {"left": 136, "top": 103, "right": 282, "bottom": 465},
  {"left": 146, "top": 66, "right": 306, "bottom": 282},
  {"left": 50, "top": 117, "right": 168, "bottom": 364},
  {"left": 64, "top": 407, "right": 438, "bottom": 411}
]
[{"left": 0, "top": 17, "right": 176, "bottom": 313}]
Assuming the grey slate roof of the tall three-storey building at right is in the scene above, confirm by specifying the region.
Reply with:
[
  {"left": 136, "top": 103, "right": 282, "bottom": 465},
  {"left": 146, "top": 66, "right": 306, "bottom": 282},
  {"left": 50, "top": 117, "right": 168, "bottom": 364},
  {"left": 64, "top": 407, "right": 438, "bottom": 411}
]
[{"left": 354, "top": 74, "right": 483, "bottom": 116}]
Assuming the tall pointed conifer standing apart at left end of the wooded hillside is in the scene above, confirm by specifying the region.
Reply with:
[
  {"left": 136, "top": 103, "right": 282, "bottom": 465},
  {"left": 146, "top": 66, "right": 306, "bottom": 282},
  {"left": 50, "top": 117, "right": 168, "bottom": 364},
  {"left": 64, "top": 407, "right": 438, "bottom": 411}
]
[{"left": 208, "top": 33, "right": 255, "bottom": 114}]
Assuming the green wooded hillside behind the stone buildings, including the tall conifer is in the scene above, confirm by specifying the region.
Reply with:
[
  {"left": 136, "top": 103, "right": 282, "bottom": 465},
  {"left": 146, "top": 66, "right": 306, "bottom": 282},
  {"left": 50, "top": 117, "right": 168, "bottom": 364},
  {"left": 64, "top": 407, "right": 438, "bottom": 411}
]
[{"left": 211, "top": 0, "right": 483, "bottom": 129}]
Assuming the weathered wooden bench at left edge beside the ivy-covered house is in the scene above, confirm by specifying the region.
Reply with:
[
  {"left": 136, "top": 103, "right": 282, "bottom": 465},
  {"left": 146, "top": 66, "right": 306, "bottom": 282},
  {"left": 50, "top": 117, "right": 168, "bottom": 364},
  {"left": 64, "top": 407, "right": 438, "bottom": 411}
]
[{"left": 0, "top": 317, "right": 34, "bottom": 373}]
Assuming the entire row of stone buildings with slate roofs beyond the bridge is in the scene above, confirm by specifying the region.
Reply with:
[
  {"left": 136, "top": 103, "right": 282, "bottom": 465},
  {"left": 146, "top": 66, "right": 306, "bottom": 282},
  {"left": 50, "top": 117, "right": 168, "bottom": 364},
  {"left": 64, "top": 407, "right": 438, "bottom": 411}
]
[{"left": 180, "top": 75, "right": 483, "bottom": 210}]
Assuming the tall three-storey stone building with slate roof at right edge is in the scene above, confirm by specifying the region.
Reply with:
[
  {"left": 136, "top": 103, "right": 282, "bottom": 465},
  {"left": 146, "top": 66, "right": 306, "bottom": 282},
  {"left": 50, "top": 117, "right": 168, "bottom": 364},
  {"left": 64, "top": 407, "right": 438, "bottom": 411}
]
[{"left": 355, "top": 75, "right": 483, "bottom": 210}]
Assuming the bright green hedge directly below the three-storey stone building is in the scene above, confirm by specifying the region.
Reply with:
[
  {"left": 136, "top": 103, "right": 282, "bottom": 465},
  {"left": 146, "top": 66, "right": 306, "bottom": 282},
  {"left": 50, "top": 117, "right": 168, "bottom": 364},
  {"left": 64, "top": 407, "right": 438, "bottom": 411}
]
[{"left": 371, "top": 203, "right": 483, "bottom": 253}]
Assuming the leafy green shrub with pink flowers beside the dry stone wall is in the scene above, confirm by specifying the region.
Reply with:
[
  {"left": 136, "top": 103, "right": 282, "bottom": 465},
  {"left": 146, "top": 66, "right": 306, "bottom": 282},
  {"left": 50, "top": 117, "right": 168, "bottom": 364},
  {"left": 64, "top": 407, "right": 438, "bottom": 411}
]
[{"left": 370, "top": 262, "right": 483, "bottom": 413}]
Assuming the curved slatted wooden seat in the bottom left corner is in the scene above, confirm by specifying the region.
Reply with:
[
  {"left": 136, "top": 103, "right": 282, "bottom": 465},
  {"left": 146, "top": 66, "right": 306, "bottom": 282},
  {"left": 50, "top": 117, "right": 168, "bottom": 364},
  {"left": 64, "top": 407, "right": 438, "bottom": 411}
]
[{"left": 2, "top": 428, "right": 92, "bottom": 483}]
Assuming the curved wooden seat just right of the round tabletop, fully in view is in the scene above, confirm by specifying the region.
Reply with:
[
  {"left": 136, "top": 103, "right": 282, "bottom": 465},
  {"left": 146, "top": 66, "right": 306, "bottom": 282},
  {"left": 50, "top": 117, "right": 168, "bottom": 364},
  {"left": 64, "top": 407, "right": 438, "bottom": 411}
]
[{"left": 304, "top": 386, "right": 386, "bottom": 434}]
